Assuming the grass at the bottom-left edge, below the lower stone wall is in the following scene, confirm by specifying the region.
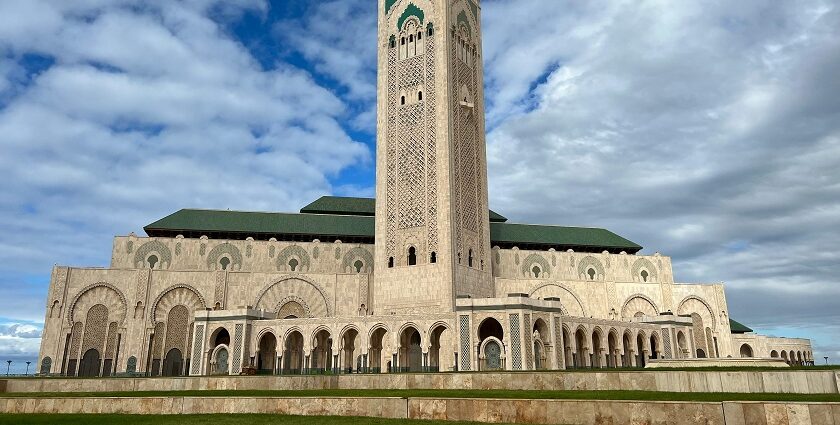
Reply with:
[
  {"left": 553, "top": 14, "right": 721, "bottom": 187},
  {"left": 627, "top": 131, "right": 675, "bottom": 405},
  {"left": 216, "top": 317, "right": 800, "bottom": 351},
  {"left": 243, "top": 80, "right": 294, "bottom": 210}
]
[{"left": 0, "top": 414, "right": 512, "bottom": 425}]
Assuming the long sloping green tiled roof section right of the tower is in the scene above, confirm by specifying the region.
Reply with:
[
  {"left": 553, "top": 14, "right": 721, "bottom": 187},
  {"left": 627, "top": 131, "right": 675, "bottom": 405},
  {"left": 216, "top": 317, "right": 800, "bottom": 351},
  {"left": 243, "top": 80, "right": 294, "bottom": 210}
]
[{"left": 490, "top": 223, "right": 642, "bottom": 254}]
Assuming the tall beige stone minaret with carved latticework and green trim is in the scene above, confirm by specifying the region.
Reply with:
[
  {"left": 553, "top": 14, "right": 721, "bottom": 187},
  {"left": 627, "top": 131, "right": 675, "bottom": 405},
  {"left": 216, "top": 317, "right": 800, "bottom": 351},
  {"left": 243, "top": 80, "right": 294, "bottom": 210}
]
[{"left": 373, "top": 0, "right": 495, "bottom": 314}]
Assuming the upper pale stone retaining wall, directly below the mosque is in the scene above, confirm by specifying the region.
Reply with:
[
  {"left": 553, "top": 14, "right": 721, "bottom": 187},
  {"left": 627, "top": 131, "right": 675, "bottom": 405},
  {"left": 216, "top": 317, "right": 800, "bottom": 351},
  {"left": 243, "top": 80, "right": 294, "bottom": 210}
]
[{"left": 0, "top": 371, "right": 840, "bottom": 394}]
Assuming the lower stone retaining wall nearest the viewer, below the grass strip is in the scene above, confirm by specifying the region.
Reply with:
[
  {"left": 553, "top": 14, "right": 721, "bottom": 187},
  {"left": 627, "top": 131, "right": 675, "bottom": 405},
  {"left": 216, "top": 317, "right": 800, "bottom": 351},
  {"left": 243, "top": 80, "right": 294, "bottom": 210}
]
[{"left": 0, "top": 397, "right": 840, "bottom": 425}]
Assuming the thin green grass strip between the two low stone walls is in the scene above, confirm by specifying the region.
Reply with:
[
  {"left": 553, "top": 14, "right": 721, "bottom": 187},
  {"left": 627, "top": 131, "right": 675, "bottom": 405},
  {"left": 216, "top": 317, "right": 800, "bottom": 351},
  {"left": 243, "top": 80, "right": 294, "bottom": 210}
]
[{"left": 0, "top": 389, "right": 840, "bottom": 403}]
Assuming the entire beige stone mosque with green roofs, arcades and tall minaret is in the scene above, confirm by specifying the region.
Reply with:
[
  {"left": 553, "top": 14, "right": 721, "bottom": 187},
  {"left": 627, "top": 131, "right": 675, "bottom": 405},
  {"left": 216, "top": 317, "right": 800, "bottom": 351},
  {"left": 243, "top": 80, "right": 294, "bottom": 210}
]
[{"left": 39, "top": 0, "right": 813, "bottom": 376}]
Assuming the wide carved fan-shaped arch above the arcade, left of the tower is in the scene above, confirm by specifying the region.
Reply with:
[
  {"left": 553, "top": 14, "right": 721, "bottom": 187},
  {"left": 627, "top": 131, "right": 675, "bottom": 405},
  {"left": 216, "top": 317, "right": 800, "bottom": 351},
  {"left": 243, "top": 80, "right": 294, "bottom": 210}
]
[{"left": 254, "top": 276, "right": 332, "bottom": 317}]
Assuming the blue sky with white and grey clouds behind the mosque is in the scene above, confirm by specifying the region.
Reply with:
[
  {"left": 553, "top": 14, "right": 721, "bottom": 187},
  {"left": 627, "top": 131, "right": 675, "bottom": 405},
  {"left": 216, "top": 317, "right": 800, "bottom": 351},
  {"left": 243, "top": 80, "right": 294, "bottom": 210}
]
[{"left": 0, "top": 0, "right": 840, "bottom": 373}]
